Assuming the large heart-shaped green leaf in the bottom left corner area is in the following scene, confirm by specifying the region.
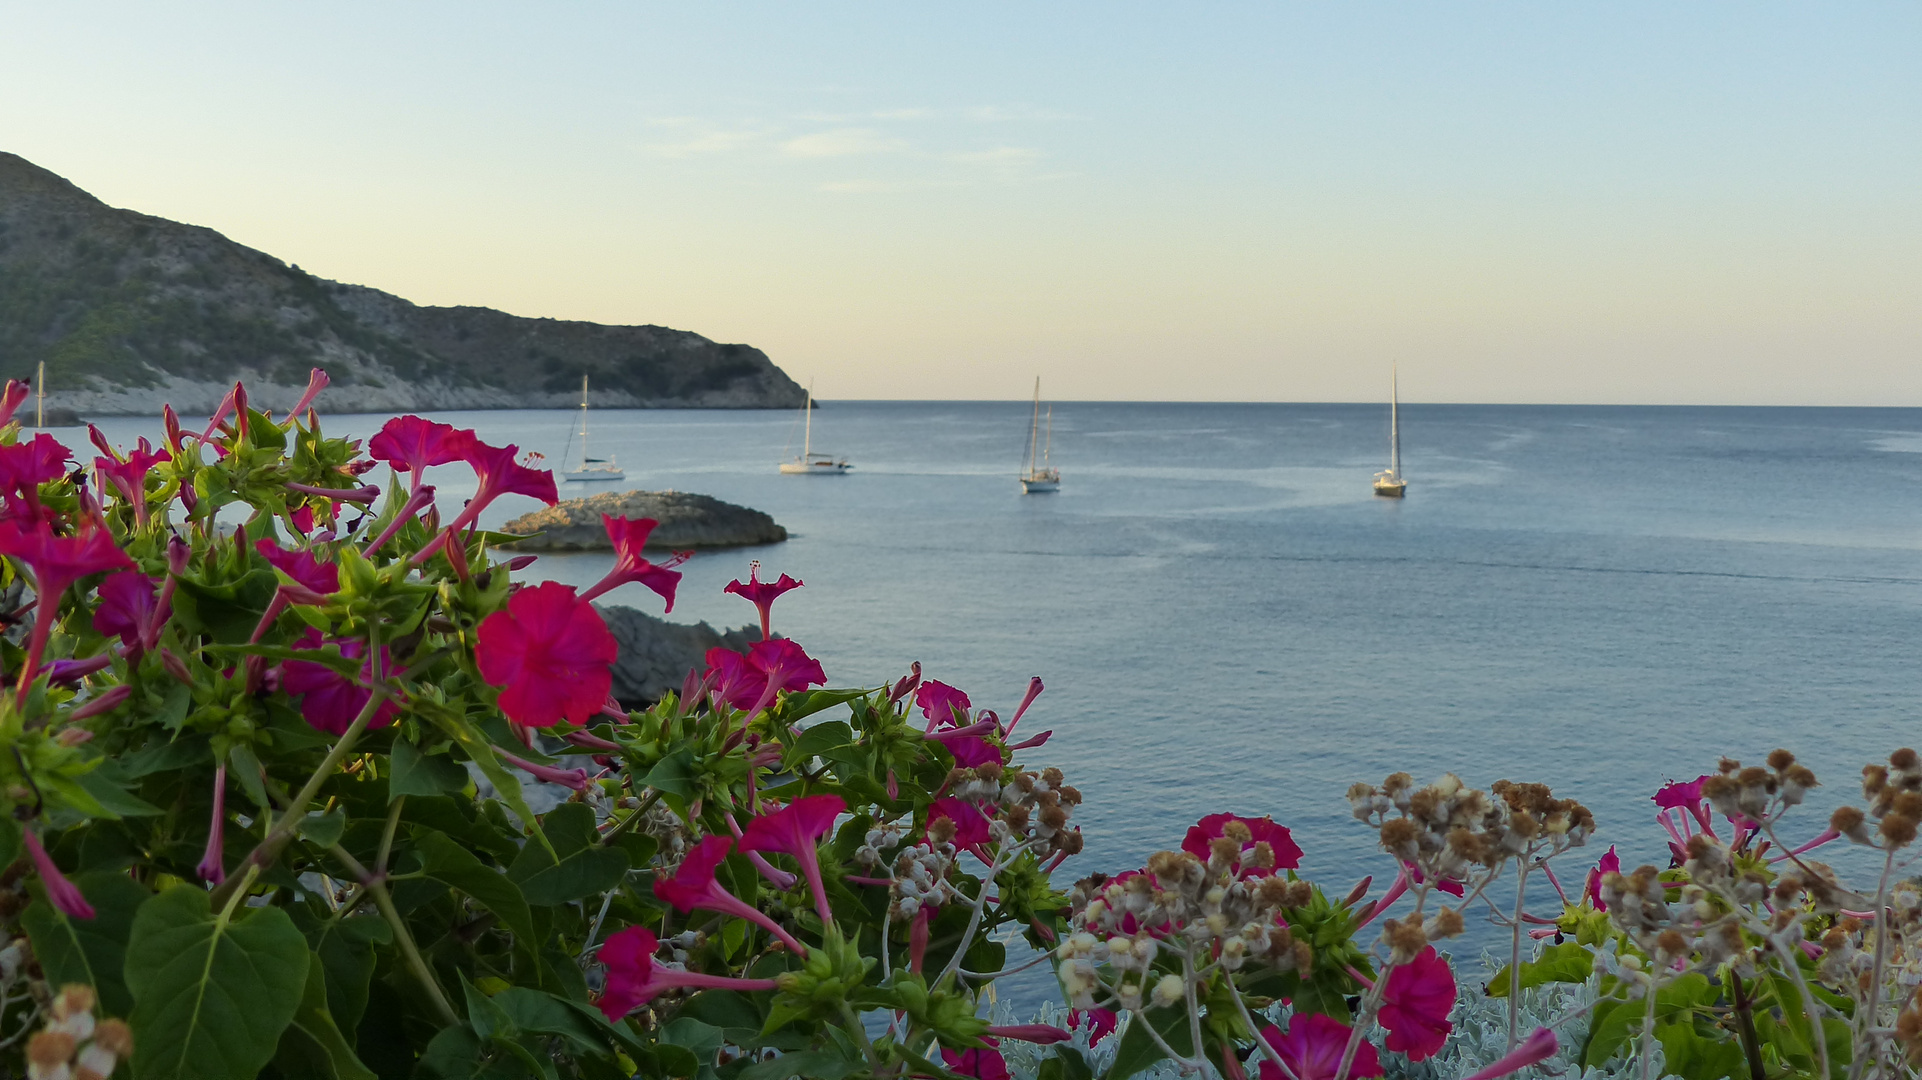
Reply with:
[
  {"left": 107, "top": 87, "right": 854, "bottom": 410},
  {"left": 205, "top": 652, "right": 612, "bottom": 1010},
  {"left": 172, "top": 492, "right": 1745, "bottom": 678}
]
[{"left": 127, "top": 886, "right": 311, "bottom": 1080}]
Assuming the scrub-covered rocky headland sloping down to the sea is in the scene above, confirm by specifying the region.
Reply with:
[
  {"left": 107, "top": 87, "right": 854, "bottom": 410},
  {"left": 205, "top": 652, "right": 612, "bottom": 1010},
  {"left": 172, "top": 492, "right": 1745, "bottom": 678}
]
[{"left": 0, "top": 154, "right": 803, "bottom": 415}]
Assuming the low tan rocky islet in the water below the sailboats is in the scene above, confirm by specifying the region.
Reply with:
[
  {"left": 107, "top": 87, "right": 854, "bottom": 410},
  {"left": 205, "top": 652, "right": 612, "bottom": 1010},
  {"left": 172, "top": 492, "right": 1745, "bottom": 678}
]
[{"left": 502, "top": 492, "right": 788, "bottom": 552}]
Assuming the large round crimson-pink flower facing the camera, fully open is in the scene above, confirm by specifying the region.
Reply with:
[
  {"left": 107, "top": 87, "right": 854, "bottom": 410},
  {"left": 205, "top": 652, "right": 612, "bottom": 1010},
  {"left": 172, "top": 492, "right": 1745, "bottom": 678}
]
[{"left": 475, "top": 580, "right": 621, "bottom": 728}]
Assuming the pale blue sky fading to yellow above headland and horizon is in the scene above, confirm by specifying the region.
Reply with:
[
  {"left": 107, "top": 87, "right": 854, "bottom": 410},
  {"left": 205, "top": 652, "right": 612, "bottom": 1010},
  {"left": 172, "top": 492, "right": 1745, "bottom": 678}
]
[{"left": 0, "top": 0, "right": 1922, "bottom": 405}]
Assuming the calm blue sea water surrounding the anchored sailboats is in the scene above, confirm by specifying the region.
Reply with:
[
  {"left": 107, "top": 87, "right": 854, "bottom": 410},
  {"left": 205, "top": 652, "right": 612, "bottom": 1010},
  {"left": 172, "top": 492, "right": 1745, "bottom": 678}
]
[{"left": 74, "top": 402, "right": 1922, "bottom": 991}]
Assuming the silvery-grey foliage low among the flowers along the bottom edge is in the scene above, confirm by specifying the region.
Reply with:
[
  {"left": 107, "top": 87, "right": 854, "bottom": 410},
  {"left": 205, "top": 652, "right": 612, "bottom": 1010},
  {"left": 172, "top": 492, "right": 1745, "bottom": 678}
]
[{"left": 994, "top": 953, "right": 1674, "bottom": 1080}]
